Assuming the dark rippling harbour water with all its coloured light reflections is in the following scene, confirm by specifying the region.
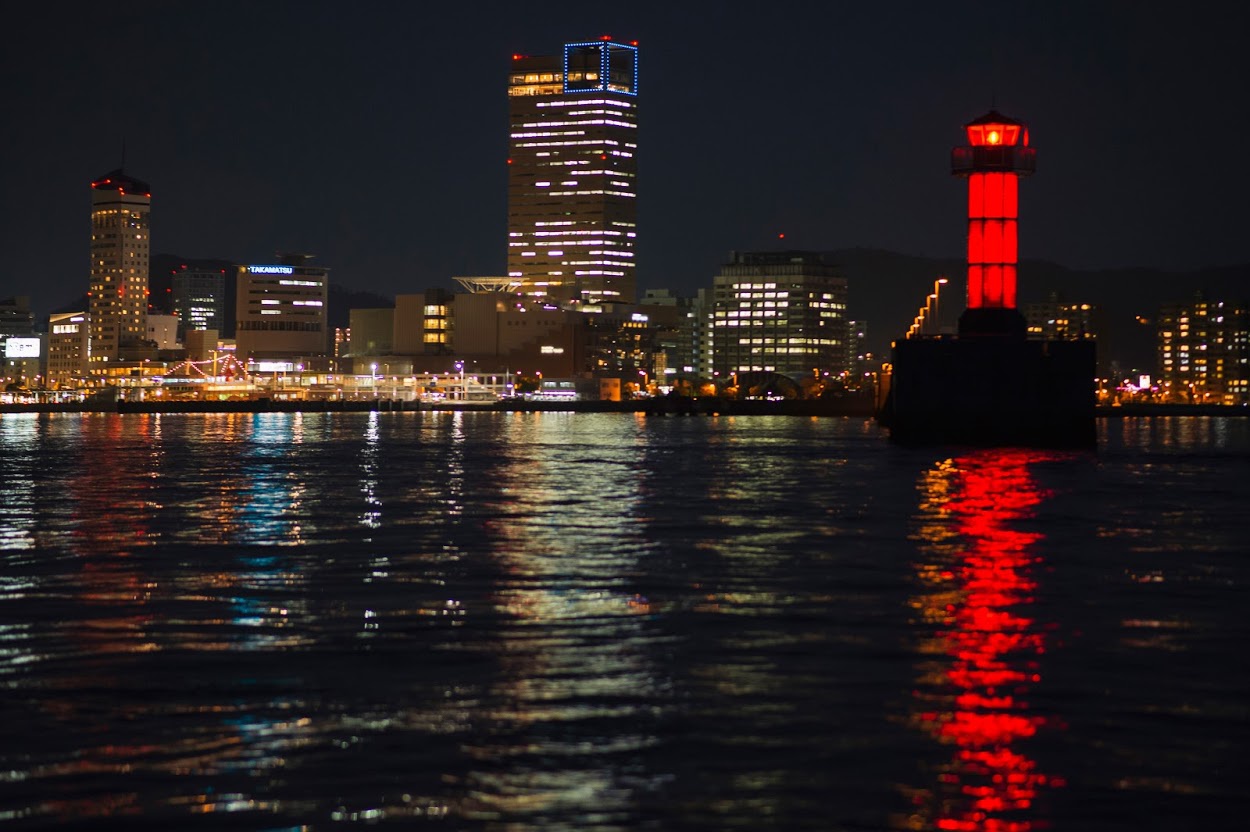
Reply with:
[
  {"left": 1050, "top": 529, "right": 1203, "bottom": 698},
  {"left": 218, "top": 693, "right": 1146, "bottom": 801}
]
[{"left": 0, "top": 414, "right": 1250, "bottom": 832}]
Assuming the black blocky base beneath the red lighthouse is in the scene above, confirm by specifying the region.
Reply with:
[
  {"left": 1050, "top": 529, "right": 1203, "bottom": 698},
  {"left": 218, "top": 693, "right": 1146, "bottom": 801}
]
[{"left": 878, "top": 335, "right": 1096, "bottom": 447}]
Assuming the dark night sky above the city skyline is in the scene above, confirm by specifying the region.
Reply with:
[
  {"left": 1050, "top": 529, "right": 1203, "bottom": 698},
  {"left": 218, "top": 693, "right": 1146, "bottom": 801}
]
[{"left": 0, "top": 0, "right": 1250, "bottom": 315}]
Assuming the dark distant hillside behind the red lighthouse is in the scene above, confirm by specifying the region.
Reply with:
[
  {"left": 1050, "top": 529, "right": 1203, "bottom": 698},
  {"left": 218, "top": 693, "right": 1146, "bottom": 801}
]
[{"left": 829, "top": 249, "right": 1250, "bottom": 370}]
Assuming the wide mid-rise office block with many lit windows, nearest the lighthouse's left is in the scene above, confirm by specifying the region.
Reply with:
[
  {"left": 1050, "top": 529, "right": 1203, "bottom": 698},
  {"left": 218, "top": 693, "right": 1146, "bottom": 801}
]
[{"left": 711, "top": 251, "right": 848, "bottom": 381}]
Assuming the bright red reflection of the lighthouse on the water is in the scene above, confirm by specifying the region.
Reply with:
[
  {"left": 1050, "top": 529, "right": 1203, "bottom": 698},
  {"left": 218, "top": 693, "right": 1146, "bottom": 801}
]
[{"left": 916, "top": 450, "right": 1061, "bottom": 832}]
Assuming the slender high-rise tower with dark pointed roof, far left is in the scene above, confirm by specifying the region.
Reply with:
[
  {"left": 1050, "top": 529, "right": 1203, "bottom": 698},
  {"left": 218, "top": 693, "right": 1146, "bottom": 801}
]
[{"left": 89, "top": 167, "right": 153, "bottom": 374}]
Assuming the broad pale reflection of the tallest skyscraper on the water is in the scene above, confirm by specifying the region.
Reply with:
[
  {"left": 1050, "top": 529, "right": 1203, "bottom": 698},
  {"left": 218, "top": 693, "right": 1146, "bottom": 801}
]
[{"left": 459, "top": 415, "right": 668, "bottom": 828}]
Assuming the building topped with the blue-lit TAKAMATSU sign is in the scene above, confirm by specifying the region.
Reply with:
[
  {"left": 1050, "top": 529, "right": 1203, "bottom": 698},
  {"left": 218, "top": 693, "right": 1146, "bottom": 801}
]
[{"left": 235, "top": 255, "right": 330, "bottom": 364}]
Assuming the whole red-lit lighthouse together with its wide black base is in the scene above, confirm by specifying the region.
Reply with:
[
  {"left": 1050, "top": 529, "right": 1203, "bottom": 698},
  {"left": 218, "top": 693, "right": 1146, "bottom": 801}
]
[{"left": 876, "top": 110, "right": 1096, "bottom": 447}]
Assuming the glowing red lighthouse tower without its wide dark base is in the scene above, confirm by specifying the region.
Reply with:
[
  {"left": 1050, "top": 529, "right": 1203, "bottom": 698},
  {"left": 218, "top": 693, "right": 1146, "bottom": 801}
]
[{"left": 950, "top": 110, "right": 1036, "bottom": 336}]
